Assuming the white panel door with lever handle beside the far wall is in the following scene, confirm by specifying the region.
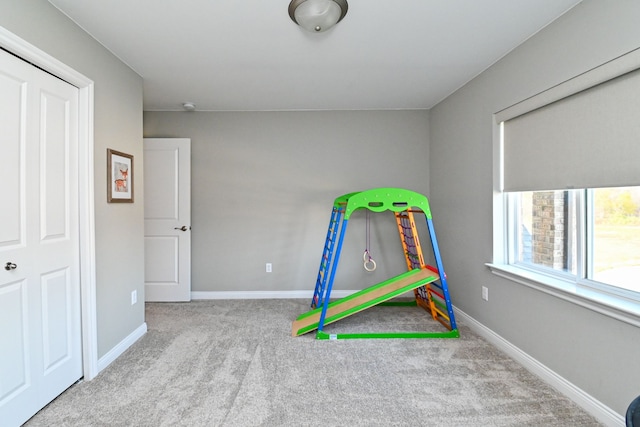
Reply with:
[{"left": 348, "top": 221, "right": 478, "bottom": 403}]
[{"left": 144, "top": 138, "right": 191, "bottom": 301}]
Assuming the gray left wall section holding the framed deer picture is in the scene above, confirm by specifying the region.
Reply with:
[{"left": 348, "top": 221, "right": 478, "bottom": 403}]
[{"left": 0, "top": 0, "right": 144, "bottom": 357}]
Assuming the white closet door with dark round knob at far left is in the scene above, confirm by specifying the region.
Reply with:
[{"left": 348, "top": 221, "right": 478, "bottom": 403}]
[{"left": 0, "top": 50, "right": 82, "bottom": 426}]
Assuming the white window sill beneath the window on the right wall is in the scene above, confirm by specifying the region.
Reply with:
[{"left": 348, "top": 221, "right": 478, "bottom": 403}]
[{"left": 485, "top": 263, "right": 640, "bottom": 327}]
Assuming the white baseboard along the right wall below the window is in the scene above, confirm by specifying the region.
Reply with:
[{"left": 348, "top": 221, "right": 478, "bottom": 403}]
[{"left": 454, "top": 307, "right": 625, "bottom": 427}]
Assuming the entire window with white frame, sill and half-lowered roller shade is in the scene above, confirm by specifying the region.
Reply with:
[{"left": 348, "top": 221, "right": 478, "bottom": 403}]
[{"left": 488, "top": 49, "right": 640, "bottom": 326}]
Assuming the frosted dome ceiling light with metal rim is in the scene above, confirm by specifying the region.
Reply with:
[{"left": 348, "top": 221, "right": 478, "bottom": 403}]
[{"left": 289, "top": 0, "right": 349, "bottom": 33}]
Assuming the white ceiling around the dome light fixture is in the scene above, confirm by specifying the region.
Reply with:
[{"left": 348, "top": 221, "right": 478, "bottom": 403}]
[{"left": 49, "top": 0, "right": 580, "bottom": 111}]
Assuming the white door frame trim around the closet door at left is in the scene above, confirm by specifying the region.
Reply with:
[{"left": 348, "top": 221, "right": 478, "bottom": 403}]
[{"left": 0, "top": 26, "right": 100, "bottom": 380}]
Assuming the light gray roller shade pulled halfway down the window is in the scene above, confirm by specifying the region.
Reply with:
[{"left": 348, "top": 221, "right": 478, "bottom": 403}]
[{"left": 504, "top": 59, "right": 640, "bottom": 191}]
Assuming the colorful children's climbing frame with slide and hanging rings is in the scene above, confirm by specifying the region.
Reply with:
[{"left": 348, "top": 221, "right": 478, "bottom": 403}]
[{"left": 291, "top": 188, "right": 460, "bottom": 339}]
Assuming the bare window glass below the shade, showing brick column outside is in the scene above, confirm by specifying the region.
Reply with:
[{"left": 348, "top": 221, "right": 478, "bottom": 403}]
[{"left": 506, "top": 187, "right": 640, "bottom": 302}]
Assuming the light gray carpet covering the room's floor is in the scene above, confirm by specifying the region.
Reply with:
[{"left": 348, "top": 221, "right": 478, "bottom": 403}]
[{"left": 26, "top": 300, "right": 600, "bottom": 427}]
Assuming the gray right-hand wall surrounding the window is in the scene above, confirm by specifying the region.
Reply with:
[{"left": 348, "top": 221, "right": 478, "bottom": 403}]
[{"left": 430, "top": 0, "right": 640, "bottom": 414}]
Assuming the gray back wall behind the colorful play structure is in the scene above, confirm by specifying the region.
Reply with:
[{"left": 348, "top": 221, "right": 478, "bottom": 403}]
[{"left": 144, "top": 111, "right": 429, "bottom": 291}]
